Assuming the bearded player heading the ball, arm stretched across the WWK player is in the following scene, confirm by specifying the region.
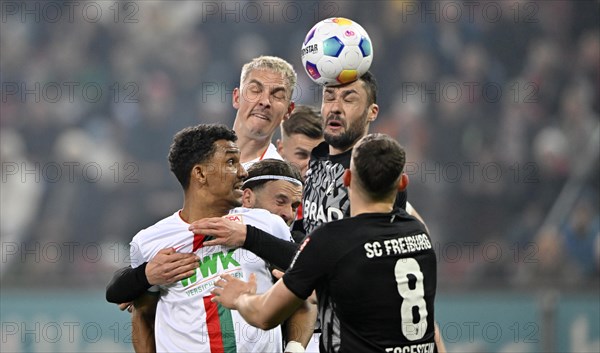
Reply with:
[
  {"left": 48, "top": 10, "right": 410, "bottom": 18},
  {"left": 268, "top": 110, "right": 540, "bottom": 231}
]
[{"left": 195, "top": 72, "right": 423, "bottom": 269}]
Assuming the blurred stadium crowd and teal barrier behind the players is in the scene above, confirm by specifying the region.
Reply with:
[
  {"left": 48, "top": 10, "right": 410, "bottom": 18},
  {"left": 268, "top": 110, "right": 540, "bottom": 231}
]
[{"left": 0, "top": 0, "right": 600, "bottom": 352}]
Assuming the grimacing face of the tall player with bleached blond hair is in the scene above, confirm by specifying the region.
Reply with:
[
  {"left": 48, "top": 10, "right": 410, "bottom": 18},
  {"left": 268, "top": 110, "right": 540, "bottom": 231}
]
[{"left": 233, "top": 70, "right": 293, "bottom": 138}]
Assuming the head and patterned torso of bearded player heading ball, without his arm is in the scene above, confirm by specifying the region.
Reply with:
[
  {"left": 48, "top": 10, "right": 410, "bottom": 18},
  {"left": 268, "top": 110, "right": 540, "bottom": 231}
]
[{"left": 303, "top": 72, "right": 406, "bottom": 234}]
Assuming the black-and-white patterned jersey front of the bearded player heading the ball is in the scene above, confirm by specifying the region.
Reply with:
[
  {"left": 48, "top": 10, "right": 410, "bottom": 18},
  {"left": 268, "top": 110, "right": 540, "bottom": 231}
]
[{"left": 302, "top": 142, "right": 406, "bottom": 234}]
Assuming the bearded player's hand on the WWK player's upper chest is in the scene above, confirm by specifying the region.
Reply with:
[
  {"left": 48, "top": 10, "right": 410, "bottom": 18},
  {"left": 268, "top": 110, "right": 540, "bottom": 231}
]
[{"left": 189, "top": 217, "right": 246, "bottom": 248}]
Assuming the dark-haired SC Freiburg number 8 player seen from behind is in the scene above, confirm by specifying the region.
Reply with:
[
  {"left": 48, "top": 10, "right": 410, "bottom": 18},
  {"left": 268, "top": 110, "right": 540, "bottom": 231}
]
[{"left": 211, "top": 134, "right": 439, "bottom": 353}]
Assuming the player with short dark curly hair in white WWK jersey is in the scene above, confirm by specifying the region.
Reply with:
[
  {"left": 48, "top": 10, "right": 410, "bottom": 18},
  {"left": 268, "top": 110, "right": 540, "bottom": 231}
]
[{"left": 131, "top": 125, "right": 289, "bottom": 352}]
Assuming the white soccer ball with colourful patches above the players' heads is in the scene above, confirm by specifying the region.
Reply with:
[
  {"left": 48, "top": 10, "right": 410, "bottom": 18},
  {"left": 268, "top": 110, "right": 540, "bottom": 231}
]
[{"left": 302, "top": 17, "right": 373, "bottom": 86}]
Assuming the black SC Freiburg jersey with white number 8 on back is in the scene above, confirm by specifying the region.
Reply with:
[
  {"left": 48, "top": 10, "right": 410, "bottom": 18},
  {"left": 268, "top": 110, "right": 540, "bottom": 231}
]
[{"left": 283, "top": 209, "right": 437, "bottom": 353}]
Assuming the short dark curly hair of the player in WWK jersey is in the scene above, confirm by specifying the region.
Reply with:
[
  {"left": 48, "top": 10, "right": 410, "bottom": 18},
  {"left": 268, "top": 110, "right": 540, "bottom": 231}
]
[{"left": 168, "top": 124, "right": 237, "bottom": 190}]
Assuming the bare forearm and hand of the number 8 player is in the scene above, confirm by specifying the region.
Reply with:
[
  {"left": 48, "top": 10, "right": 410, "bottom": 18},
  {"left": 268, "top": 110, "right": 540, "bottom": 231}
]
[{"left": 211, "top": 275, "right": 304, "bottom": 330}]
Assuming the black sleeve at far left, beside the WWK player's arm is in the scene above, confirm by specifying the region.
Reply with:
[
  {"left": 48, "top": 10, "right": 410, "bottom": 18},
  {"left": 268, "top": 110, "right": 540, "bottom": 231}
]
[{"left": 106, "top": 262, "right": 151, "bottom": 304}]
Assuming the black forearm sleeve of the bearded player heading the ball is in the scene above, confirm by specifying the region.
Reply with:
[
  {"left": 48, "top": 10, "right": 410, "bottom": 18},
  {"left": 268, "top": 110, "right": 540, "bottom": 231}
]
[{"left": 242, "top": 225, "right": 298, "bottom": 269}]
